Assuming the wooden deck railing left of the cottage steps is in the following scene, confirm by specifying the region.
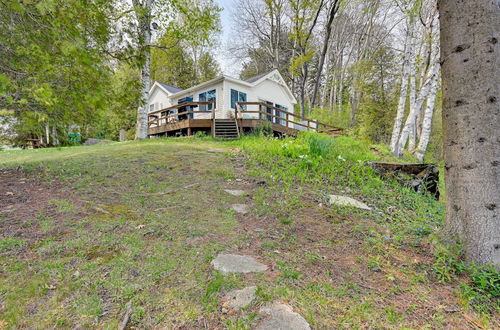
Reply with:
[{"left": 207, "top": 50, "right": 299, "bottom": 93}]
[{"left": 148, "top": 102, "right": 215, "bottom": 128}]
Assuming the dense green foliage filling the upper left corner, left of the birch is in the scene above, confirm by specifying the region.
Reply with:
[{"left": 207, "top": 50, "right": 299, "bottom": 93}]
[{"left": 0, "top": 0, "right": 112, "bottom": 144}]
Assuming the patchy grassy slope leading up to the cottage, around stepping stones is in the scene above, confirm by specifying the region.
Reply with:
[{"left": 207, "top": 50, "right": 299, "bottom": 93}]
[{"left": 0, "top": 137, "right": 492, "bottom": 328}]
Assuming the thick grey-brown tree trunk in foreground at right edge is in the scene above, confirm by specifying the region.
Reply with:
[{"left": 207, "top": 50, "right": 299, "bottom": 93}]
[{"left": 439, "top": 0, "right": 500, "bottom": 269}]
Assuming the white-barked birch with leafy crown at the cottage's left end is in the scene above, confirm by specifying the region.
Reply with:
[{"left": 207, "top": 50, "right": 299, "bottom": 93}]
[{"left": 116, "top": 0, "right": 220, "bottom": 139}]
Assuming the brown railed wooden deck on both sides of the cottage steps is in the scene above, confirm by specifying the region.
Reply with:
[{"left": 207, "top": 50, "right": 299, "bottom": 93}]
[{"left": 148, "top": 102, "right": 343, "bottom": 137}]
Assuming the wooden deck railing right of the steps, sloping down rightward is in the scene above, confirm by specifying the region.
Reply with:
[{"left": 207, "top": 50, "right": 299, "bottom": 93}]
[{"left": 234, "top": 102, "right": 344, "bottom": 135}]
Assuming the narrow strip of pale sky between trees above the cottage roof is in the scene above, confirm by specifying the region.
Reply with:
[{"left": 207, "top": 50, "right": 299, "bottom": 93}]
[{"left": 216, "top": 0, "right": 241, "bottom": 77}]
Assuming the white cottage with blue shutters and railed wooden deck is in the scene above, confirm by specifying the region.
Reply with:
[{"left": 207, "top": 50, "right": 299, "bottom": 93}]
[{"left": 148, "top": 70, "right": 341, "bottom": 138}]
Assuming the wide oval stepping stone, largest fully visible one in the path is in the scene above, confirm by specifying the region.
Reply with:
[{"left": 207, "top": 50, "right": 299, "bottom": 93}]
[{"left": 212, "top": 253, "right": 267, "bottom": 275}]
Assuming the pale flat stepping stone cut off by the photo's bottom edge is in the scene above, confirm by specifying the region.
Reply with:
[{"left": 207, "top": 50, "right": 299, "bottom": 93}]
[{"left": 255, "top": 303, "right": 311, "bottom": 330}]
